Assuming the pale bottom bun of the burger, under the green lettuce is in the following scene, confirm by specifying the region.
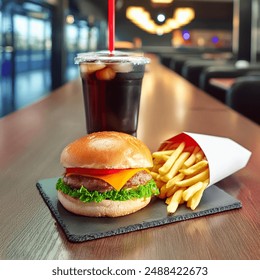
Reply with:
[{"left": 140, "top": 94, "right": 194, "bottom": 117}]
[{"left": 58, "top": 191, "right": 151, "bottom": 217}]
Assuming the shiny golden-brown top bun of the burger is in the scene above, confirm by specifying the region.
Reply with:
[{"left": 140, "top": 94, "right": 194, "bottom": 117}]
[{"left": 60, "top": 131, "right": 153, "bottom": 169}]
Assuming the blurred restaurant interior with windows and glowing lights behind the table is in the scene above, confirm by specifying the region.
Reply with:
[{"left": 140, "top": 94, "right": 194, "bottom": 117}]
[{"left": 0, "top": 0, "right": 260, "bottom": 123}]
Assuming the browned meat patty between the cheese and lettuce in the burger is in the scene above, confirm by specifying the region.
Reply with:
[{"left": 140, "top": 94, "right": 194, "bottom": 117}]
[{"left": 63, "top": 170, "right": 152, "bottom": 192}]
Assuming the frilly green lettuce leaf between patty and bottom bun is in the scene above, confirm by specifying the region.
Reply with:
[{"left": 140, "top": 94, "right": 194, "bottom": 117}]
[{"left": 56, "top": 178, "right": 159, "bottom": 202}]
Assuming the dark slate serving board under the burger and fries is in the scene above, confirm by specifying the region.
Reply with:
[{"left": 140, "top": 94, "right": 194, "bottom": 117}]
[{"left": 36, "top": 178, "right": 242, "bottom": 242}]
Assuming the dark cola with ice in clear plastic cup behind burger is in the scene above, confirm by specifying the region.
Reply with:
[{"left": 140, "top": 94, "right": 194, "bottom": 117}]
[{"left": 75, "top": 52, "right": 148, "bottom": 136}]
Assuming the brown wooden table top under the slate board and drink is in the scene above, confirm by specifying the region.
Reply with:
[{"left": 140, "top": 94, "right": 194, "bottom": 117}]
[{"left": 0, "top": 57, "right": 260, "bottom": 260}]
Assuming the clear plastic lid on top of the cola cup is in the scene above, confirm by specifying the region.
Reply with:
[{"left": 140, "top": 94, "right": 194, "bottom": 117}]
[{"left": 74, "top": 51, "right": 150, "bottom": 64}]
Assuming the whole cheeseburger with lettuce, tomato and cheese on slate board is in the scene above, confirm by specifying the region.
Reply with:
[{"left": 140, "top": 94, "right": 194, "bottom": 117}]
[{"left": 56, "top": 131, "right": 159, "bottom": 217}]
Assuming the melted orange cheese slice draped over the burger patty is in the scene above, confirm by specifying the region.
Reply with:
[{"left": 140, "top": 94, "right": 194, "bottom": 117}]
[{"left": 67, "top": 168, "right": 149, "bottom": 191}]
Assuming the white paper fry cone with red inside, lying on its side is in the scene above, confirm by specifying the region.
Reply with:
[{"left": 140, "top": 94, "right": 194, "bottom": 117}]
[{"left": 159, "top": 132, "right": 251, "bottom": 187}]
